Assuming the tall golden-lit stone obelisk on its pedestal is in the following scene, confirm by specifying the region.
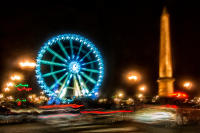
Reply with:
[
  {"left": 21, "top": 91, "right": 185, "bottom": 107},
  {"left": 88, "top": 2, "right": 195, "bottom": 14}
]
[{"left": 158, "top": 8, "right": 174, "bottom": 97}]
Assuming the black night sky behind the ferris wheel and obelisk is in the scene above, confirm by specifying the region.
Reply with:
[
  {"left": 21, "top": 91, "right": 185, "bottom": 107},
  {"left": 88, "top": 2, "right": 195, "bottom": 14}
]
[{"left": 0, "top": 0, "right": 200, "bottom": 95}]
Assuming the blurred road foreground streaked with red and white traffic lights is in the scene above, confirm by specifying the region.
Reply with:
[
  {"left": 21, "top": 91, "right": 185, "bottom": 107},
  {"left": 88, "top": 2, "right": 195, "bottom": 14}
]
[{"left": 0, "top": 106, "right": 200, "bottom": 133}]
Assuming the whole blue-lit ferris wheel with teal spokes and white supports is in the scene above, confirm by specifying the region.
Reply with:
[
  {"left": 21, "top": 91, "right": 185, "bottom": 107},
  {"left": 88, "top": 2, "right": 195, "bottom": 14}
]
[{"left": 36, "top": 34, "right": 104, "bottom": 103}]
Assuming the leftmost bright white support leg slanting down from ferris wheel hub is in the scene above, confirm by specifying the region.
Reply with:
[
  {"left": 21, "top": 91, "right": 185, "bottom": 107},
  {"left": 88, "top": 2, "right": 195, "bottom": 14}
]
[{"left": 59, "top": 73, "right": 72, "bottom": 98}]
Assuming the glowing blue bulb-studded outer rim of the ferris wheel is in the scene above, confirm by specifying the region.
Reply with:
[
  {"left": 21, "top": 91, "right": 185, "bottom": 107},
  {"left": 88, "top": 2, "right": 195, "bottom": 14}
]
[{"left": 36, "top": 34, "right": 104, "bottom": 100}]
